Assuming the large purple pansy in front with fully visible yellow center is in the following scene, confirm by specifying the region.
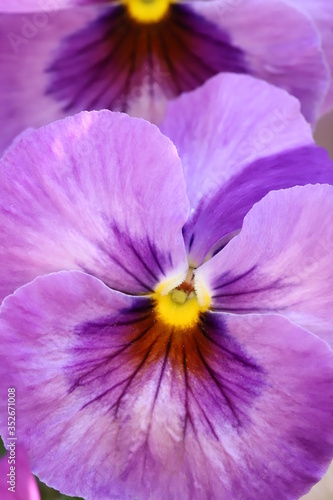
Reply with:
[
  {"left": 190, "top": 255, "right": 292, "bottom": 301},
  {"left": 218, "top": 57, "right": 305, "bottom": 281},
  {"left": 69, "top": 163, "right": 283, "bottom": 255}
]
[{"left": 0, "top": 75, "right": 333, "bottom": 500}]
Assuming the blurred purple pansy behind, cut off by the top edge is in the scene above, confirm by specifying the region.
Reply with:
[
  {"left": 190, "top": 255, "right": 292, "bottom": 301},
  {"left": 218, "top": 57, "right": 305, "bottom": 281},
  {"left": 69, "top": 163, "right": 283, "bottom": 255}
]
[{"left": 0, "top": 0, "right": 331, "bottom": 154}]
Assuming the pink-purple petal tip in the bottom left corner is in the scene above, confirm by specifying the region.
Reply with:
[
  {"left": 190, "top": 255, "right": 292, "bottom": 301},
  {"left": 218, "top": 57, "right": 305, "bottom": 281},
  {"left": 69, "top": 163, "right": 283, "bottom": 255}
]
[{"left": 0, "top": 448, "right": 40, "bottom": 500}]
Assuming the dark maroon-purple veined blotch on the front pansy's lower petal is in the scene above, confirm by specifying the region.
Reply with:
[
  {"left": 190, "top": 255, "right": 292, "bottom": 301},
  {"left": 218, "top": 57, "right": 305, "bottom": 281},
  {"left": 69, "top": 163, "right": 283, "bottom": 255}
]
[{"left": 66, "top": 298, "right": 265, "bottom": 444}]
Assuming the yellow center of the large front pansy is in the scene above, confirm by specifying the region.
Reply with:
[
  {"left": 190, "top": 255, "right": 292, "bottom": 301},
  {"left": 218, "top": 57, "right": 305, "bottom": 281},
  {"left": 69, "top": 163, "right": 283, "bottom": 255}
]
[{"left": 154, "top": 272, "right": 210, "bottom": 328}]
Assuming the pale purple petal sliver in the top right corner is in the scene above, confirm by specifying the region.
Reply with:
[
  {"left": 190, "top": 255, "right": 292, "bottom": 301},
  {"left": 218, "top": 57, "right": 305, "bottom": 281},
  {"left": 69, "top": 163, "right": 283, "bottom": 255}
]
[{"left": 286, "top": 0, "right": 333, "bottom": 113}]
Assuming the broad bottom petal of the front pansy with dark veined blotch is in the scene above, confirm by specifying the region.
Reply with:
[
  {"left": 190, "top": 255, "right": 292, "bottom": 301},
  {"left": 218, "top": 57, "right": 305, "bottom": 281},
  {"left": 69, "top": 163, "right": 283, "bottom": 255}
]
[{"left": 0, "top": 272, "right": 333, "bottom": 500}]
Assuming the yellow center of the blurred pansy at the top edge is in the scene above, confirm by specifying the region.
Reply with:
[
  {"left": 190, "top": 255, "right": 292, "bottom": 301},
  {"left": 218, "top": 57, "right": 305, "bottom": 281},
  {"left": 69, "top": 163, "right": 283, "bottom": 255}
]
[{"left": 122, "top": 0, "right": 172, "bottom": 23}]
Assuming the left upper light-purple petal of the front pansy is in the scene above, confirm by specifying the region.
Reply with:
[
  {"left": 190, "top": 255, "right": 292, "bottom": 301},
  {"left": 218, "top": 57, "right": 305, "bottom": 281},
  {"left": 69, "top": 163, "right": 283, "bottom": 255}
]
[{"left": 0, "top": 111, "right": 188, "bottom": 299}]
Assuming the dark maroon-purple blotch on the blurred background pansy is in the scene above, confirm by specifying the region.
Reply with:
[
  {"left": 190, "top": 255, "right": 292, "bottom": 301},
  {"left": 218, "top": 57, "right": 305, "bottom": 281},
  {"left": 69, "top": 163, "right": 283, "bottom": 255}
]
[{"left": 47, "top": 4, "right": 248, "bottom": 113}]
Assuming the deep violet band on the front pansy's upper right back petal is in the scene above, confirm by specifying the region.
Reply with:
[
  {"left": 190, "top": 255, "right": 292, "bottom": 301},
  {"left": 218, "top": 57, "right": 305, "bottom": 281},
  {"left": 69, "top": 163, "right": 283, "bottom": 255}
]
[{"left": 183, "top": 145, "right": 333, "bottom": 264}]
